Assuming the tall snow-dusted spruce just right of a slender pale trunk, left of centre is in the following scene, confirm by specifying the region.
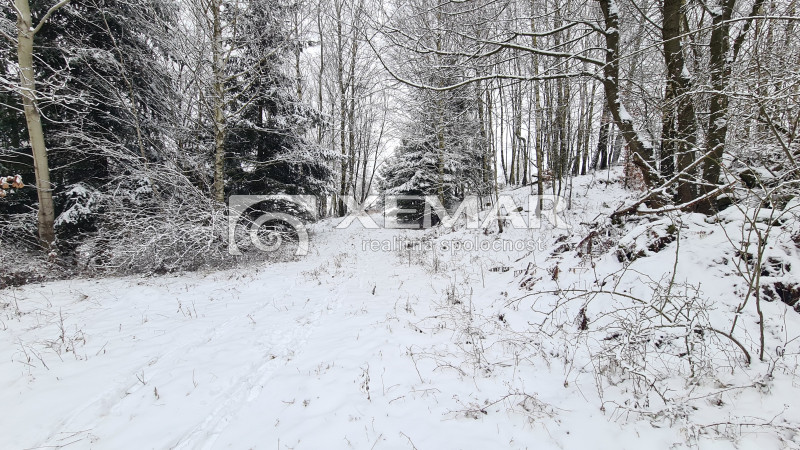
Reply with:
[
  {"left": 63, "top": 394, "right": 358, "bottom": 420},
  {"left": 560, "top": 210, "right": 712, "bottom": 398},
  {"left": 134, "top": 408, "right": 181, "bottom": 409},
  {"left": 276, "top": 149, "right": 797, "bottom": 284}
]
[{"left": 225, "top": 0, "right": 335, "bottom": 194}]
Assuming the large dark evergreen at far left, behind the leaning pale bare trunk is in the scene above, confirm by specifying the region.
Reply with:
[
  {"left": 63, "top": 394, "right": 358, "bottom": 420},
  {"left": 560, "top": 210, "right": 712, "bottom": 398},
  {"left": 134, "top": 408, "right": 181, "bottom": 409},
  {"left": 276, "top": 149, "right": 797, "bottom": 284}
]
[{"left": 0, "top": 0, "right": 177, "bottom": 234}]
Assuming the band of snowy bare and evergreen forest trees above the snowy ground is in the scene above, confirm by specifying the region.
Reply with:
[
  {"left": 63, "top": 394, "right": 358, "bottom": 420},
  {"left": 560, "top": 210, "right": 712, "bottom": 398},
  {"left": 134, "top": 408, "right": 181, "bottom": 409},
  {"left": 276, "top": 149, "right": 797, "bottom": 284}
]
[{"left": 0, "top": 0, "right": 800, "bottom": 272}]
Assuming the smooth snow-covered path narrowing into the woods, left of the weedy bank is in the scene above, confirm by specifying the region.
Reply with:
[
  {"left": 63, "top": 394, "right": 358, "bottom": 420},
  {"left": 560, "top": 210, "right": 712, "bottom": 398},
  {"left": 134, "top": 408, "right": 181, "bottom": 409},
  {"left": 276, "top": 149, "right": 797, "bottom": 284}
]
[{"left": 0, "top": 223, "right": 488, "bottom": 449}]
